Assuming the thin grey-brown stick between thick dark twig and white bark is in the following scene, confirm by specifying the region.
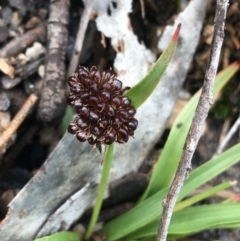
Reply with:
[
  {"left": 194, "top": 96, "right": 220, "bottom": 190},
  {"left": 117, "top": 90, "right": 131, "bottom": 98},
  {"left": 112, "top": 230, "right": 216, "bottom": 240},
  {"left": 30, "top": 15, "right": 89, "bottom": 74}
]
[{"left": 67, "top": 0, "right": 95, "bottom": 76}]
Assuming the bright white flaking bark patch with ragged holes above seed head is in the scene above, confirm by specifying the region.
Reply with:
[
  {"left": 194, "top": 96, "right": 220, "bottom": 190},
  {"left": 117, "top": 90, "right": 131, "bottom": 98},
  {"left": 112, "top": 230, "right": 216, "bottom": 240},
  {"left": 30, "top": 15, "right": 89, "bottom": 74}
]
[{"left": 95, "top": 0, "right": 156, "bottom": 86}]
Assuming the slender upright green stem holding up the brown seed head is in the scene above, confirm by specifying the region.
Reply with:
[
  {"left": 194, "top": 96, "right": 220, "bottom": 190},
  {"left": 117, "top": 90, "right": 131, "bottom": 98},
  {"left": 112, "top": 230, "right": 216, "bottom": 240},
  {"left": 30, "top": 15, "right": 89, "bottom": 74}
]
[{"left": 85, "top": 144, "right": 114, "bottom": 239}]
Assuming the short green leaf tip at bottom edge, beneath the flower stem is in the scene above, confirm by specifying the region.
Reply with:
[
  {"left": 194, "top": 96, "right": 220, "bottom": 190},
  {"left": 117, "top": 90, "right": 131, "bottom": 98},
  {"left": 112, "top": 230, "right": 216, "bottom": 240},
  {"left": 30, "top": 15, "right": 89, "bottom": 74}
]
[{"left": 35, "top": 232, "right": 81, "bottom": 241}]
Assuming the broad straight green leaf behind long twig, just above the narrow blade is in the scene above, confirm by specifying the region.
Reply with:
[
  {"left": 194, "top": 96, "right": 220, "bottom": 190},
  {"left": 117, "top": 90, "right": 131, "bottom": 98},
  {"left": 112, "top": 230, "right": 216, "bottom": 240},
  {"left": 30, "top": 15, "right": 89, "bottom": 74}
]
[{"left": 103, "top": 144, "right": 240, "bottom": 241}]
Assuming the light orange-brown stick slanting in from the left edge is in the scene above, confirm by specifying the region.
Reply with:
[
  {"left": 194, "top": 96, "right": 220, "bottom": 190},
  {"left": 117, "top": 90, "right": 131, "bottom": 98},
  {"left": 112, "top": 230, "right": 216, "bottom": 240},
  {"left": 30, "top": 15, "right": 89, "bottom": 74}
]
[{"left": 0, "top": 94, "right": 38, "bottom": 150}]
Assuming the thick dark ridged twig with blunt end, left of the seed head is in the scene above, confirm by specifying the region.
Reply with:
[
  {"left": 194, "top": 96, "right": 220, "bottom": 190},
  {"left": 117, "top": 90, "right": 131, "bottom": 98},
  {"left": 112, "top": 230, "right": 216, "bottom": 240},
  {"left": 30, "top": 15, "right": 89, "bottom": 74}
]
[{"left": 38, "top": 0, "right": 69, "bottom": 125}]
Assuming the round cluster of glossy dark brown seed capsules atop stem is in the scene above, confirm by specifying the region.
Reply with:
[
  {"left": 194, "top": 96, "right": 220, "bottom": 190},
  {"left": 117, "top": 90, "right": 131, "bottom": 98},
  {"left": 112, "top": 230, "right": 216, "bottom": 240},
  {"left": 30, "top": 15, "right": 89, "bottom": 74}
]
[{"left": 66, "top": 66, "right": 138, "bottom": 146}]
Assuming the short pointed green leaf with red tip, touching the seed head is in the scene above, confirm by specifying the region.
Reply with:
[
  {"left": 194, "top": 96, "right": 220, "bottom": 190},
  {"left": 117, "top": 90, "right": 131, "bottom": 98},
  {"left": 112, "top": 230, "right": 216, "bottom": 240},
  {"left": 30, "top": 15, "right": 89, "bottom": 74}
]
[{"left": 125, "top": 24, "right": 181, "bottom": 108}]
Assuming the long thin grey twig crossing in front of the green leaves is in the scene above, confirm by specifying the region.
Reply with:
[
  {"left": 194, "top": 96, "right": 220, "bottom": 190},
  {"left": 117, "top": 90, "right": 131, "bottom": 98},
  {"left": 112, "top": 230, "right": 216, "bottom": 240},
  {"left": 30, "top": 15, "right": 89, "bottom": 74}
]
[{"left": 156, "top": 0, "right": 228, "bottom": 241}]
